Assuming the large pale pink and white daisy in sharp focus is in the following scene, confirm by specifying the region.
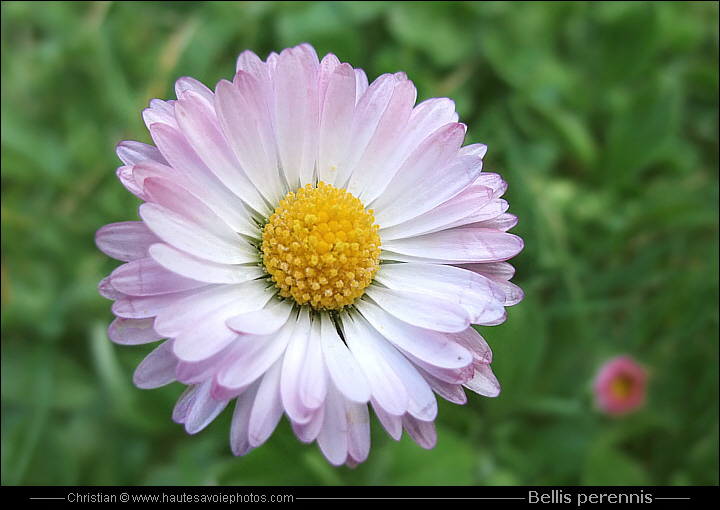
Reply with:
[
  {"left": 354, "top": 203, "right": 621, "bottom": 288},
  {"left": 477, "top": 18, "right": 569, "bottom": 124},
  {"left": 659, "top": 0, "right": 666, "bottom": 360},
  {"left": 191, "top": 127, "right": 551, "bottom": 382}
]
[{"left": 96, "top": 44, "right": 523, "bottom": 465}]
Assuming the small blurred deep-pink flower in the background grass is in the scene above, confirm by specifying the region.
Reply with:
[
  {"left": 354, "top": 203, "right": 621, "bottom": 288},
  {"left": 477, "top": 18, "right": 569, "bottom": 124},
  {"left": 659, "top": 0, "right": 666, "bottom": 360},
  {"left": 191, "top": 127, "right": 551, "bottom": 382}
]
[{"left": 593, "top": 356, "right": 647, "bottom": 416}]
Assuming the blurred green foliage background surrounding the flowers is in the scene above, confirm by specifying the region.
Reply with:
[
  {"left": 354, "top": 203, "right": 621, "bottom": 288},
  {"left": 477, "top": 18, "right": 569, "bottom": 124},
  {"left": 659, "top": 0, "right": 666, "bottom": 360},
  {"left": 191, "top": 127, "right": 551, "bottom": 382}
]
[{"left": 1, "top": 2, "right": 718, "bottom": 485}]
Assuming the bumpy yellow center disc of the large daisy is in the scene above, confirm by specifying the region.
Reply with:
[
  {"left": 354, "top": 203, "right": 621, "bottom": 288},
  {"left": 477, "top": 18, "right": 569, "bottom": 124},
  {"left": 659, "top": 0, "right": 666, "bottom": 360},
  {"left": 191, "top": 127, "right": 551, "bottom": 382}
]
[{"left": 262, "top": 182, "right": 380, "bottom": 310}]
